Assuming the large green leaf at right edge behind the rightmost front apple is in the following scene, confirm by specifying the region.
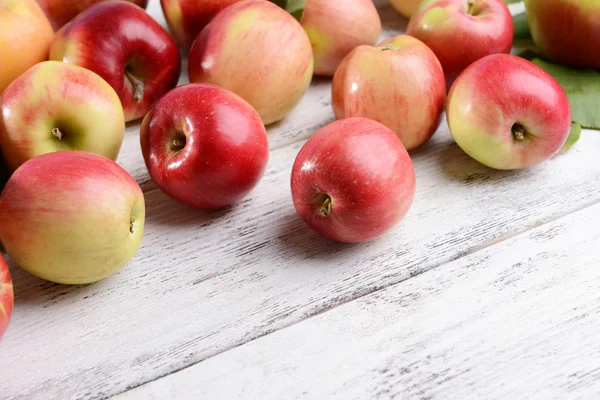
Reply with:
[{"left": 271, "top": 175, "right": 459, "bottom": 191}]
[{"left": 531, "top": 57, "right": 600, "bottom": 129}]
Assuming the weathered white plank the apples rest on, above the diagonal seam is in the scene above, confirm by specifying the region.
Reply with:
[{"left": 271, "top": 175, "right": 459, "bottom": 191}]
[{"left": 0, "top": 0, "right": 600, "bottom": 399}]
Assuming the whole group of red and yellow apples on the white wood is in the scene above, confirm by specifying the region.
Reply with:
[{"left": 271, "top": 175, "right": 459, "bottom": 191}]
[{"left": 0, "top": 0, "right": 600, "bottom": 337}]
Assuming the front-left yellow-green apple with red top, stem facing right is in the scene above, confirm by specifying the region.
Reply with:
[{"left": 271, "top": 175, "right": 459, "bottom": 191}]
[{"left": 0, "top": 150, "right": 145, "bottom": 284}]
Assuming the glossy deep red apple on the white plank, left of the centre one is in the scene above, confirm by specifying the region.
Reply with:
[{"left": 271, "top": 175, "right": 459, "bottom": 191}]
[{"left": 140, "top": 83, "right": 269, "bottom": 208}]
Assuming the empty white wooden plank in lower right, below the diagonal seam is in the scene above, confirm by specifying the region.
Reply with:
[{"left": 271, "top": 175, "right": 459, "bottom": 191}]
[{"left": 115, "top": 205, "right": 600, "bottom": 400}]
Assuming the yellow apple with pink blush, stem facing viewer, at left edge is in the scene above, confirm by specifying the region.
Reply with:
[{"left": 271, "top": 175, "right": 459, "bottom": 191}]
[{"left": 0, "top": 61, "right": 125, "bottom": 171}]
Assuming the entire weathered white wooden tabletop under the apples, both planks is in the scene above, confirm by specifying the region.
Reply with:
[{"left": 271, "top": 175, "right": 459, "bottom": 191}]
[{"left": 0, "top": 0, "right": 600, "bottom": 400}]
